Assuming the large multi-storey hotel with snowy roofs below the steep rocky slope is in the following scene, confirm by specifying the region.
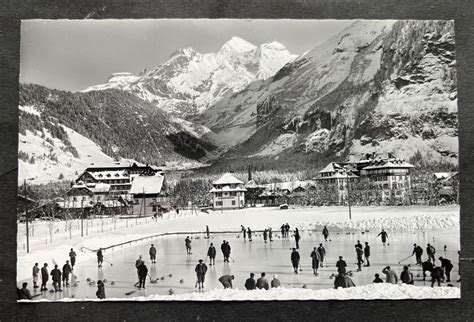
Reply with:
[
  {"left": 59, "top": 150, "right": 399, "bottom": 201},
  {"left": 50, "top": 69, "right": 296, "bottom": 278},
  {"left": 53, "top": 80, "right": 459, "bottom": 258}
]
[{"left": 317, "top": 155, "right": 413, "bottom": 204}]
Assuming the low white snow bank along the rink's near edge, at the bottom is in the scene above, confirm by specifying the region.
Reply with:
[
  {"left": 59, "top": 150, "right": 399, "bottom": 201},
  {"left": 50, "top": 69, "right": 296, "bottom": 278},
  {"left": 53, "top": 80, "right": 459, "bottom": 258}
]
[{"left": 20, "top": 283, "right": 461, "bottom": 303}]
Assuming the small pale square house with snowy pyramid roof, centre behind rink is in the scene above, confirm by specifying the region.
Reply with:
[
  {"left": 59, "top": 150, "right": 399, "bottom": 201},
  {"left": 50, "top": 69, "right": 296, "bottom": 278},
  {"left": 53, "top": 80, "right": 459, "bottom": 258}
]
[{"left": 210, "top": 173, "right": 247, "bottom": 210}]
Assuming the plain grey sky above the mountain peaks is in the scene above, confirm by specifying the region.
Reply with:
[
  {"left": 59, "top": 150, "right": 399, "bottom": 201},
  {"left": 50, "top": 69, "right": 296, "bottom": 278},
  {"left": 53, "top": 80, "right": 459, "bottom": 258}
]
[{"left": 20, "top": 19, "right": 352, "bottom": 91}]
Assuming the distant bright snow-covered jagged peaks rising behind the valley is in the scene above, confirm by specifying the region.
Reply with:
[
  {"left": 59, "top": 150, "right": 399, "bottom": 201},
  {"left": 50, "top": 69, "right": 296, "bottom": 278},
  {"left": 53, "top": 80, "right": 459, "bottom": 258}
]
[{"left": 85, "top": 37, "right": 296, "bottom": 117}]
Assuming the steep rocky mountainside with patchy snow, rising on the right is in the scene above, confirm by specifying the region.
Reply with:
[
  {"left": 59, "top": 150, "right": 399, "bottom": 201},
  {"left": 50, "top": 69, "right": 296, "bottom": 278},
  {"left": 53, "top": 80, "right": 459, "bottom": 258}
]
[{"left": 206, "top": 20, "right": 458, "bottom": 169}]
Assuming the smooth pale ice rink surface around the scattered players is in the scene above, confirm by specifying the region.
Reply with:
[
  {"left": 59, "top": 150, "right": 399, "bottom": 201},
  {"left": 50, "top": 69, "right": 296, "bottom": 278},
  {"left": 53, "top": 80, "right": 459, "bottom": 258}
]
[{"left": 18, "top": 227, "right": 459, "bottom": 300}]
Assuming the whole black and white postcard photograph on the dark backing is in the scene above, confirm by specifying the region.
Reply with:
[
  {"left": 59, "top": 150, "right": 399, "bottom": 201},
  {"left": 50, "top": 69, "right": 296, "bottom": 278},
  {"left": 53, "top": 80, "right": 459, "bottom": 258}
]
[{"left": 14, "top": 19, "right": 461, "bottom": 305}]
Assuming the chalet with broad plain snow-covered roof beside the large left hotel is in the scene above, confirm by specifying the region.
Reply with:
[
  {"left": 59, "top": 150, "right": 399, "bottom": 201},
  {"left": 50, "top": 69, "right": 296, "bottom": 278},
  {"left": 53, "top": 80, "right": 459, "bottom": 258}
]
[{"left": 130, "top": 174, "right": 171, "bottom": 216}]
